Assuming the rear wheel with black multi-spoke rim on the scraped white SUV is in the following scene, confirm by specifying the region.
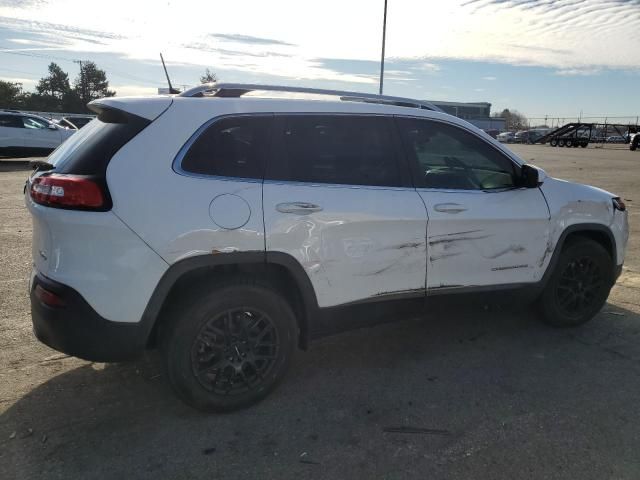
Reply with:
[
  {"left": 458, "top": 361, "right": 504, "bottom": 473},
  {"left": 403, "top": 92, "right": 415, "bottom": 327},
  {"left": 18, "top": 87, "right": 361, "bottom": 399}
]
[{"left": 161, "top": 280, "right": 297, "bottom": 412}]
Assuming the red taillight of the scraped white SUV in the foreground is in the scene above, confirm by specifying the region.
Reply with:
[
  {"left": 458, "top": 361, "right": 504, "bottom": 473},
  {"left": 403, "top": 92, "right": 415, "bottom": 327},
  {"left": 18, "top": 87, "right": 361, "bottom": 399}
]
[{"left": 29, "top": 173, "right": 106, "bottom": 209}]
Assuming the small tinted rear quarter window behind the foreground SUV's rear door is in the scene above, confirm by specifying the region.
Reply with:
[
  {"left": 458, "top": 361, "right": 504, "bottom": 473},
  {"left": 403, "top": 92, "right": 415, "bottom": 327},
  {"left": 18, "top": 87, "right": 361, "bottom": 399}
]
[{"left": 181, "top": 116, "right": 273, "bottom": 179}]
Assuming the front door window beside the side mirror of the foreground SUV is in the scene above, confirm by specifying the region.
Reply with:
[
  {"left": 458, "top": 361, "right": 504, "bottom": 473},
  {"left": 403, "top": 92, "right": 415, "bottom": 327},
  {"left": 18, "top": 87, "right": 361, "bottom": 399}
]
[{"left": 398, "top": 118, "right": 515, "bottom": 190}]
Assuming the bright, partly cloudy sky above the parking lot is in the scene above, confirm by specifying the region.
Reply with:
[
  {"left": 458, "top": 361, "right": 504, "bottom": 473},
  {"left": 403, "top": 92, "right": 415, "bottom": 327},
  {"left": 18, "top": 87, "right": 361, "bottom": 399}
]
[{"left": 0, "top": 0, "right": 640, "bottom": 121}]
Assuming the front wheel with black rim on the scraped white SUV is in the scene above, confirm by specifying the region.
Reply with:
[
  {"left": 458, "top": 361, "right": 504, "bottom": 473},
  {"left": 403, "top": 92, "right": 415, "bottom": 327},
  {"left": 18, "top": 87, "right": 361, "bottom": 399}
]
[{"left": 538, "top": 238, "right": 613, "bottom": 327}]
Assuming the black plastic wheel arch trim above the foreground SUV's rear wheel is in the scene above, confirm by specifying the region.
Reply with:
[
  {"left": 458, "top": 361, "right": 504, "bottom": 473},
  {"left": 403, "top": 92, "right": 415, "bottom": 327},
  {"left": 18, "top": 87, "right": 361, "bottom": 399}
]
[{"left": 141, "top": 251, "right": 318, "bottom": 349}]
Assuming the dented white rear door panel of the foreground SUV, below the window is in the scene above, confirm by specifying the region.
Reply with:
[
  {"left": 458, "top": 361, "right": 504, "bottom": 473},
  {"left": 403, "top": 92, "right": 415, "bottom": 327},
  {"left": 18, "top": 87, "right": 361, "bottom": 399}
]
[{"left": 264, "top": 181, "right": 427, "bottom": 307}]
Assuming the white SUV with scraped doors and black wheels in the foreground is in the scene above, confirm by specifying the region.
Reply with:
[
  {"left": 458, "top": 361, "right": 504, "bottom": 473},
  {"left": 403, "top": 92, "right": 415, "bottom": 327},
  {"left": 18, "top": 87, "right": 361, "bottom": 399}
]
[{"left": 26, "top": 84, "right": 628, "bottom": 411}]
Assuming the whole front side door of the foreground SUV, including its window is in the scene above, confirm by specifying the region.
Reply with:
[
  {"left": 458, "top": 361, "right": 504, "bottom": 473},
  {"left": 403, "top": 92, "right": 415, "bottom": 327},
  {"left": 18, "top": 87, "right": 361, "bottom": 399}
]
[{"left": 396, "top": 118, "right": 549, "bottom": 292}]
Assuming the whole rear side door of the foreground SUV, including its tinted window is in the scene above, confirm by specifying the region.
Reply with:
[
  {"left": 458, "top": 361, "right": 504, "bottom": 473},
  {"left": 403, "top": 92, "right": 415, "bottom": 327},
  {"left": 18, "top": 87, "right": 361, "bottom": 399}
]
[{"left": 263, "top": 114, "right": 427, "bottom": 307}]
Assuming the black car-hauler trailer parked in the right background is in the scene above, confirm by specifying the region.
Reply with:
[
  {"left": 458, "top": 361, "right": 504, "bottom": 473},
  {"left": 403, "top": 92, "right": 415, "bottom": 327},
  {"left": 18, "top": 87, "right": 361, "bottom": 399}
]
[{"left": 536, "top": 122, "right": 640, "bottom": 148}]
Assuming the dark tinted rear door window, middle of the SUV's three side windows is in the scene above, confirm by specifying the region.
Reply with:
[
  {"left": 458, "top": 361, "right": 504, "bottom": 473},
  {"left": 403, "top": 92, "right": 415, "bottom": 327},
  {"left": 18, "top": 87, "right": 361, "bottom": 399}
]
[{"left": 267, "top": 115, "right": 401, "bottom": 187}]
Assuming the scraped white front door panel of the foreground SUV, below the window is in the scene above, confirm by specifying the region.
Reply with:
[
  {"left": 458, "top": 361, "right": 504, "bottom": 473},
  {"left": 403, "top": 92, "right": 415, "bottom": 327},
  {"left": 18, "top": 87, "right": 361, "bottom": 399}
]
[{"left": 419, "top": 188, "right": 549, "bottom": 290}]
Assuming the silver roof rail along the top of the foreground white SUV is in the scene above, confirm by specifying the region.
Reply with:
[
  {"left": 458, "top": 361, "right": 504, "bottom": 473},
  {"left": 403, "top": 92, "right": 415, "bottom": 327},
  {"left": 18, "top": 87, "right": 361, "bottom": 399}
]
[{"left": 179, "top": 83, "right": 442, "bottom": 112}]
